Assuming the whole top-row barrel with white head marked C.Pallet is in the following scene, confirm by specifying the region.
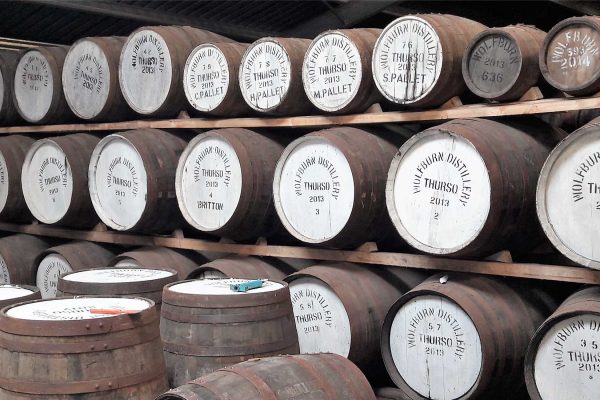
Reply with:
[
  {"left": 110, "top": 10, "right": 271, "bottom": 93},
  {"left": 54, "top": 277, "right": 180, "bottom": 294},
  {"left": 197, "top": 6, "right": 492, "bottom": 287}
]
[{"left": 183, "top": 43, "right": 251, "bottom": 118}]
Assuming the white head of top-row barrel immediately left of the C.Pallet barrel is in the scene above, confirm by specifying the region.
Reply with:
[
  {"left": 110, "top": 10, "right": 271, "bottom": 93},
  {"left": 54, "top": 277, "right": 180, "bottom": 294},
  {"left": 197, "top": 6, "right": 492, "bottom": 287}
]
[{"left": 119, "top": 29, "right": 172, "bottom": 114}]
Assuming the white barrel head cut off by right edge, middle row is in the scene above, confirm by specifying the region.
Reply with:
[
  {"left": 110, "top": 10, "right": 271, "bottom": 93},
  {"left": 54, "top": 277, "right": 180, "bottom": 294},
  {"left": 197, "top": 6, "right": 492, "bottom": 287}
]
[{"left": 537, "top": 130, "right": 600, "bottom": 269}]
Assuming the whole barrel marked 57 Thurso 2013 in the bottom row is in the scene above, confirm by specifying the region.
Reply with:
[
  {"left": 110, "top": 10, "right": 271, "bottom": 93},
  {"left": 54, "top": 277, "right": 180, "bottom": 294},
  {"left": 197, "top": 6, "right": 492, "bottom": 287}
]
[{"left": 381, "top": 273, "right": 556, "bottom": 400}]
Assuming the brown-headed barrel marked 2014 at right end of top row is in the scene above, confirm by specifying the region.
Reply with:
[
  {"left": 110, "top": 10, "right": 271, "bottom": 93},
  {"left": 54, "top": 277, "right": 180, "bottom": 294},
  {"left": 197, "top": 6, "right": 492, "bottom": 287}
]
[{"left": 539, "top": 16, "right": 600, "bottom": 96}]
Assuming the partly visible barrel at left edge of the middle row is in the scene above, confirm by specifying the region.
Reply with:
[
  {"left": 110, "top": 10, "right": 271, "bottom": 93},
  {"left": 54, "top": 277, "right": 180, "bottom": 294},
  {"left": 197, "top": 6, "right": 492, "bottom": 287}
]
[{"left": 0, "top": 135, "right": 35, "bottom": 222}]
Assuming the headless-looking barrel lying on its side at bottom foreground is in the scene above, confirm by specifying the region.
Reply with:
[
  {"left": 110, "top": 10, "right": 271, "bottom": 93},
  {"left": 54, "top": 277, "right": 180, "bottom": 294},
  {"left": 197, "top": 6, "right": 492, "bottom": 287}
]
[{"left": 156, "top": 354, "right": 375, "bottom": 400}]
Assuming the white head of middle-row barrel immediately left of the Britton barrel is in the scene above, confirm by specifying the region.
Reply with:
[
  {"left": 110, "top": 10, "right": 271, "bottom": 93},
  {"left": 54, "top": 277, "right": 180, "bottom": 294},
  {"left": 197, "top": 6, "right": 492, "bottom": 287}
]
[{"left": 88, "top": 134, "right": 151, "bottom": 231}]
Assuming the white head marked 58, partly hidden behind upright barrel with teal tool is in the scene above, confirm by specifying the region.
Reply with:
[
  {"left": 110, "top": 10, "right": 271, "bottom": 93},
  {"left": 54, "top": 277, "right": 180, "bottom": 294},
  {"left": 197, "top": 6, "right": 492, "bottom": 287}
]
[{"left": 290, "top": 277, "right": 352, "bottom": 357}]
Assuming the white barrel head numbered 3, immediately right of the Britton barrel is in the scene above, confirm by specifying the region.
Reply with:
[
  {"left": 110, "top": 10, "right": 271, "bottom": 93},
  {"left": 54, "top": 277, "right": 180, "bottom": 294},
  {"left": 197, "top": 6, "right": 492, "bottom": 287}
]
[{"left": 273, "top": 136, "right": 354, "bottom": 243}]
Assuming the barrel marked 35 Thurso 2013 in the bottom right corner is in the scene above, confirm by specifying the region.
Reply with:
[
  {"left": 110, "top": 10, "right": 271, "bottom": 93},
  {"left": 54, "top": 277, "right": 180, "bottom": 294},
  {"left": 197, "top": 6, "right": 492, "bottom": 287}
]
[{"left": 525, "top": 286, "right": 600, "bottom": 400}]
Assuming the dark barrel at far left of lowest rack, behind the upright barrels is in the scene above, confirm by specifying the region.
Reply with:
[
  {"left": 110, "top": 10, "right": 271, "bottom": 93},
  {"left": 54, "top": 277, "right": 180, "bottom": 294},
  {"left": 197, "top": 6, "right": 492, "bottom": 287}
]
[{"left": 0, "top": 234, "right": 48, "bottom": 285}]
